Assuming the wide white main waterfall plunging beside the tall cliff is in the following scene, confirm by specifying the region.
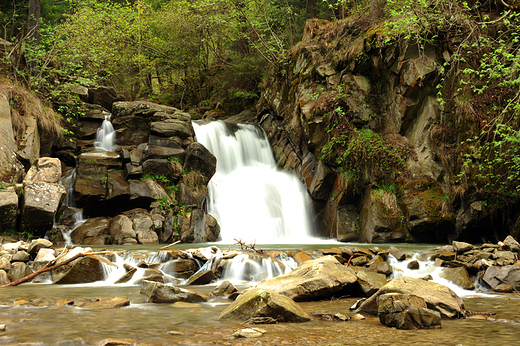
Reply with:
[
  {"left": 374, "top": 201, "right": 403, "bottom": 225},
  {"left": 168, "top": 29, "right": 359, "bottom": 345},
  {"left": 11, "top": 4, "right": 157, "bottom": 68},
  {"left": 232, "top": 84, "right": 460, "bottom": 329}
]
[{"left": 193, "top": 121, "right": 316, "bottom": 244}]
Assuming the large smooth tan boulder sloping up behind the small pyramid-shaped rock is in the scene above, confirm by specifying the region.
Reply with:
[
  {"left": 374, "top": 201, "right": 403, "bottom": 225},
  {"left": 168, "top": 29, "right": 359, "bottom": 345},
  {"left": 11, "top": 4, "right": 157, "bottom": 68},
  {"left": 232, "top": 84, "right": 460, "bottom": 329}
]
[{"left": 256, "top": 256, "right": 357, "bottom": 301}]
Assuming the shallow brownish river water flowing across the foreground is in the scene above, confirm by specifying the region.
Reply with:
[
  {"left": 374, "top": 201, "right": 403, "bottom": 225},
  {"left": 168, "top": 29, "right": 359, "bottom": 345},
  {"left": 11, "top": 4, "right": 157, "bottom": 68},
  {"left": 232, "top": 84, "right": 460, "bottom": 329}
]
[{"left": 0, "top": 268, "right": 520, "bottom": 346}]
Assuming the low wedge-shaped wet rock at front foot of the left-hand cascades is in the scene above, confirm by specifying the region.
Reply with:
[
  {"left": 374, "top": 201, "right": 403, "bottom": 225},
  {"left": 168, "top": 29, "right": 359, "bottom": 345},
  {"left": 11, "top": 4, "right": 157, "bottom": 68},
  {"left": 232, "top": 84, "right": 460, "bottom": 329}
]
[{"left": 141, "top": 280, "right": 209, "bottom": 303}]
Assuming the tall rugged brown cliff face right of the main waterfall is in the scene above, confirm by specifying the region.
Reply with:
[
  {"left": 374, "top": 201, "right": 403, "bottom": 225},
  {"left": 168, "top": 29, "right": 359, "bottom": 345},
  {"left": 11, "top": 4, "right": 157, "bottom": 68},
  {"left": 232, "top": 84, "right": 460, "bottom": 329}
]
[{"left": 257, "top": 19, "right": 517, "bottom": 242}]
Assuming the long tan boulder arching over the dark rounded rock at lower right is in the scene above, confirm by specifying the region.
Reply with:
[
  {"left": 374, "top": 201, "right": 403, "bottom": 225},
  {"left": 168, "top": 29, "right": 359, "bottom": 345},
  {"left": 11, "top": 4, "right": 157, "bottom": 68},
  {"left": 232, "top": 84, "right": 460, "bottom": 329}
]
[{"left": 359, "top": 276, "right": 464, "bottom": 318}]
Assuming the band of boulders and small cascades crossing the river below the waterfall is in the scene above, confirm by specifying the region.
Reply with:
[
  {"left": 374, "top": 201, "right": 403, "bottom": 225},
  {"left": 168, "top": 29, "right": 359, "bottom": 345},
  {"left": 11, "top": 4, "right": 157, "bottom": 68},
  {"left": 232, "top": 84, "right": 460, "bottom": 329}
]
[{"left": 0, "top": 237, "right": 520, "bottom": 329}]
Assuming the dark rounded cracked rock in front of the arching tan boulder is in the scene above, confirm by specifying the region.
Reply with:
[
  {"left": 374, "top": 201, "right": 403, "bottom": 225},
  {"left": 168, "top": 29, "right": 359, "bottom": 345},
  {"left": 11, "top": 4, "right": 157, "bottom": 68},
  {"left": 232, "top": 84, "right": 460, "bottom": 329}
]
[{"left": 377, "top": 293, "right": 441, "bottom": 329}]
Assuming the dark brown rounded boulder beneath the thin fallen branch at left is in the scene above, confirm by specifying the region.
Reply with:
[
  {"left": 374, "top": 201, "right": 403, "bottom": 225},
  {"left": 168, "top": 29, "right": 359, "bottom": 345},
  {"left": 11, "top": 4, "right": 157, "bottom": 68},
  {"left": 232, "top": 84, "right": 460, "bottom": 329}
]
[{"left": 52, "top": 256, "right": 105, "bottom": 284}]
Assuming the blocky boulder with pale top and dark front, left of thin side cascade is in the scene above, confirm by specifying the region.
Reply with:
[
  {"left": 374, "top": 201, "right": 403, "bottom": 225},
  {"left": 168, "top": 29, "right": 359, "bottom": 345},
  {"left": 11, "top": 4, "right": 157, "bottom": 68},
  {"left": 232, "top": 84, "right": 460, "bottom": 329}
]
[{"left": 21, "top": 182, "right": 66, "bottom": 236}]
